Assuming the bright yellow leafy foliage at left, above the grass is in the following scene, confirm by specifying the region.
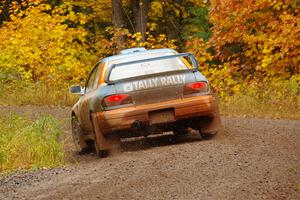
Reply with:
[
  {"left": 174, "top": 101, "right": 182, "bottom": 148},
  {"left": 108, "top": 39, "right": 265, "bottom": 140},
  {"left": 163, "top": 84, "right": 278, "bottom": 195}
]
[{"left": 0, "top": 4, "right": 97, "bottom": 85}]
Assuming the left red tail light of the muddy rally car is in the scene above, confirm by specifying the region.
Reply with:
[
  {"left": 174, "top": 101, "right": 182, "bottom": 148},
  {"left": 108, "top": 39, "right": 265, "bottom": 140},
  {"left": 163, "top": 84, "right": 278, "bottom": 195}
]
[{"left": 102, "top": 94, "right": 132, "bottom": 107}]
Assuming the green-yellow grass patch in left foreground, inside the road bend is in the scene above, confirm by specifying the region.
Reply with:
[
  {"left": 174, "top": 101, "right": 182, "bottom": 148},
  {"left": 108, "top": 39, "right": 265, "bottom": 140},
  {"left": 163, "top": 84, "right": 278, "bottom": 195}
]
[{"left": 0, "top": 113, "right": 65, "bottom": 175}]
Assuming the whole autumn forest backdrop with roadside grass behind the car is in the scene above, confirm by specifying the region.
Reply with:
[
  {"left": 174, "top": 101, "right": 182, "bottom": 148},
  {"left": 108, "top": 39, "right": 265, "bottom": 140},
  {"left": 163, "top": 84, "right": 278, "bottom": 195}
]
[{"left": 0, "top": 0, "right": 300, "bottom": 119}]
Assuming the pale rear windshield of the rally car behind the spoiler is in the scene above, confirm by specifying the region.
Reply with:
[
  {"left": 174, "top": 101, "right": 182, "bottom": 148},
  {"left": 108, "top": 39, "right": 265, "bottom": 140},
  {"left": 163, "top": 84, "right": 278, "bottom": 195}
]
[{"left": 108, "top": 54, "right": 191, "bottom": 81}]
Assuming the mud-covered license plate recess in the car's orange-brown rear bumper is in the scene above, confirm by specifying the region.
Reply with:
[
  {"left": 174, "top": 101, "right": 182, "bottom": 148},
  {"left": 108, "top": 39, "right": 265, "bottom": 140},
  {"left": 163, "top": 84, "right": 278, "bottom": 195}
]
[{"left": 149, "top": 109, "right": 175, "bottom": 124}]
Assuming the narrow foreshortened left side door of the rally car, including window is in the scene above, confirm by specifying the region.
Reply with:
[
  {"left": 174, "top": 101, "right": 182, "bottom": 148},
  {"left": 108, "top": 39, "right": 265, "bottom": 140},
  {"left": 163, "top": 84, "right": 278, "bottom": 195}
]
[{"left": 80, "top": 63, "right": 100, "bottom": 131}]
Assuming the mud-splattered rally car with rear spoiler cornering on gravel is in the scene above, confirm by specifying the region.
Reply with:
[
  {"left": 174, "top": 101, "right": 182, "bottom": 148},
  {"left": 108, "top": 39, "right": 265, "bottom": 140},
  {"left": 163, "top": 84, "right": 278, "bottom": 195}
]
[{"left": 70, "top": 48, "right": 221, "bottom": 157}]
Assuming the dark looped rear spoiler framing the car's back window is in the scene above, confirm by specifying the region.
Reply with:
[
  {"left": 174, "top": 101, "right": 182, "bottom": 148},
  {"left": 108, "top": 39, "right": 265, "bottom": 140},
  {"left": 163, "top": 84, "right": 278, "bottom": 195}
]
[{"left": 105, "top": 53, "right": 198, "bottom": 84}]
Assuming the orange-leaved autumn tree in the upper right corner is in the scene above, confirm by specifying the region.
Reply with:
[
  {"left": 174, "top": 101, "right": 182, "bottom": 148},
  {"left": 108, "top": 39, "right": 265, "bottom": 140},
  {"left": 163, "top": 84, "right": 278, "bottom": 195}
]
[{"left": 211, "top": 0, "right": 300, "bottom": 80}]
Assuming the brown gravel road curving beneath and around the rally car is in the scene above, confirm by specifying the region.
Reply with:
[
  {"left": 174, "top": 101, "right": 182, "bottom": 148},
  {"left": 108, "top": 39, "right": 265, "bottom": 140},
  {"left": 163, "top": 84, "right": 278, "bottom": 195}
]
[{"left": 0, "top": 107, "right": 300, "bottom": 200}]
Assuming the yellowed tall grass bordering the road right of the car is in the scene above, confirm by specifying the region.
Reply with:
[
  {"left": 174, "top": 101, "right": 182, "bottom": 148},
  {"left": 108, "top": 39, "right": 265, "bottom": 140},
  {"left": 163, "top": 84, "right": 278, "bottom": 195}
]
[{"left": 219, "top": 80, "right": 300, "bottom": 119}]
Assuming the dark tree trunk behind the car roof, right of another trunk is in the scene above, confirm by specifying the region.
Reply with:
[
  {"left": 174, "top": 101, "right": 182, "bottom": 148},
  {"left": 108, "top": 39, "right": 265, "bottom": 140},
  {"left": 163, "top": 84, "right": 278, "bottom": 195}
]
[{"left": 132, "top": 0, "right": 150, "bottom": 41}]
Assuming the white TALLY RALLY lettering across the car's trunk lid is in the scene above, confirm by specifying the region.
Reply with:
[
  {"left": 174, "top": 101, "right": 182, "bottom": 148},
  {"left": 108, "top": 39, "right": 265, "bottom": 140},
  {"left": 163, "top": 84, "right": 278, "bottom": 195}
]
[{"left": 123, "top": 75, "right": 186, "bottom": 92}]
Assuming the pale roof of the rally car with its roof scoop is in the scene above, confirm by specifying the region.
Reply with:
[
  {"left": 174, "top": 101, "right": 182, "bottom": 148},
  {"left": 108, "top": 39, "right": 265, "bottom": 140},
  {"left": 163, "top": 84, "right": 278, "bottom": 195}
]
[{"left": 101, "top": 48, "right": 177, "bottom": 62}]
